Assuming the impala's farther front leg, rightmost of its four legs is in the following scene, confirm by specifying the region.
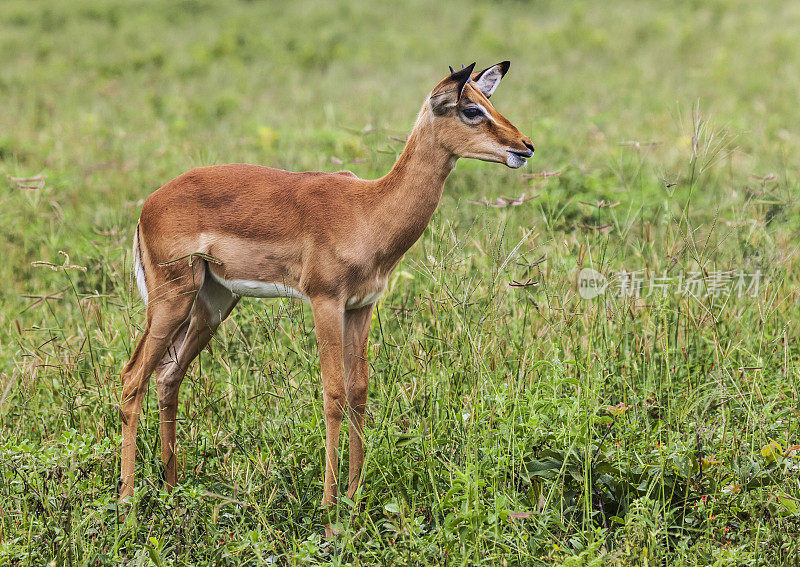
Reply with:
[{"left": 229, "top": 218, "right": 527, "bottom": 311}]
[{"left": 344, "top": 304, "right": 374, "bottom": 498}]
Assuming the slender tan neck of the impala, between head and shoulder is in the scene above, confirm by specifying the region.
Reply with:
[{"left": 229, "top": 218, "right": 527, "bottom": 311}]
[{"left": 378, "top": 102, "right": 456, "bottom": 259}]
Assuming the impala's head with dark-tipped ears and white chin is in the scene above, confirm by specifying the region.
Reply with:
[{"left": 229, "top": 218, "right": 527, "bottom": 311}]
[{"left": 428, "top": 61, "right": 533, "bottom": 168}]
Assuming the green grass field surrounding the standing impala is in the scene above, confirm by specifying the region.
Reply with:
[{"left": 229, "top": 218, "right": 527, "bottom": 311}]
[{"left": 0, "top": 0, "right": 800, "bottom": 566}]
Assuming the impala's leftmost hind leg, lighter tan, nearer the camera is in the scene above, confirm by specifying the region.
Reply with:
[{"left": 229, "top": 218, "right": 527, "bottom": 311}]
[{"left": 119, "top": 294, "right": 193, "bottom": 499}]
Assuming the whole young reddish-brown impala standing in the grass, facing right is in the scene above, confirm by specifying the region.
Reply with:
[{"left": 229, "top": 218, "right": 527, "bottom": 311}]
[{"left": 120, "top": 61, "right": 533, "bottom": 528}]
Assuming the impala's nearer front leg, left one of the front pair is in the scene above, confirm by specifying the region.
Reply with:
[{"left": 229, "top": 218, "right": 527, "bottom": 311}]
[{"left": 311, "top": 299, "right": 345, "bottom": 524}]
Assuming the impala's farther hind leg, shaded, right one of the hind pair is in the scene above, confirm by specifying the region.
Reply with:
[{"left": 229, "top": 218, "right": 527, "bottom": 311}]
[{"left": 156, "top": 278, "right": 238, "bottom": 490}]
